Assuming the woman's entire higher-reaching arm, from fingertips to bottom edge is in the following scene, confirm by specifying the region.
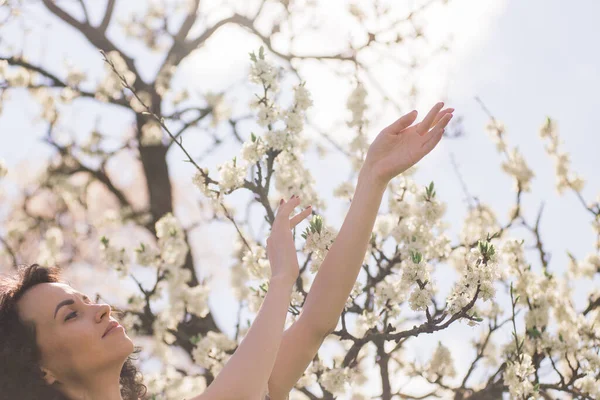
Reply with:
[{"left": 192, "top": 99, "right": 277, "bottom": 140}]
[{"left": 268, "top": 103, "right": 453, "bottom": 400}]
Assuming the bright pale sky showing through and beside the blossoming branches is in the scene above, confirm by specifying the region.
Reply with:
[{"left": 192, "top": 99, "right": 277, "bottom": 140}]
[{"left": 0, "top": 0, "right": 600, "bottom": 393}]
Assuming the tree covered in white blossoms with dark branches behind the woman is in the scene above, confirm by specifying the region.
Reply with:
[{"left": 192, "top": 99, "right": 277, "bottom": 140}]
[{"left": 0, "top": 0, "right": 600, "bottom": 400}]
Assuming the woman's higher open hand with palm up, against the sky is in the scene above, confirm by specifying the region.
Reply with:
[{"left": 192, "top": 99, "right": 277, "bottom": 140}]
[{"left": 363, "top": 102, "right": 454, "bottom": 185}]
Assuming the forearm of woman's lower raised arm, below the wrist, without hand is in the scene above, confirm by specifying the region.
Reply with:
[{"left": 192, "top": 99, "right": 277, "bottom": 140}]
[{"left": 207, "top": 278, "right": 293, "bottom": 399}]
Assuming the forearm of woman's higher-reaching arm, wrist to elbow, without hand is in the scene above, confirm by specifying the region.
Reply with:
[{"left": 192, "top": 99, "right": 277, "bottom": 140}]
[{"left": 302, "top": 170, "right": 387, "bottom": 334}]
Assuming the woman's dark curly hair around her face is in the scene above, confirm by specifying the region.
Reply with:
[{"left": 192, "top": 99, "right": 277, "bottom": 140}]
[{"left": 0, "top": 264, "right": 147, "bottom": 400}]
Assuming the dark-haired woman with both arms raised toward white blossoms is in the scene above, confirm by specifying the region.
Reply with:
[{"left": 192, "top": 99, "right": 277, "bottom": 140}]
[{"left": 0, "top": 103, "right": 453, "bottom": 400}]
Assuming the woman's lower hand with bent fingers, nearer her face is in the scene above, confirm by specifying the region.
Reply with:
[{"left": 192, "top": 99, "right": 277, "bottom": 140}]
[{"left": 267, "top": 195, "right": 312, "bottom": 285}]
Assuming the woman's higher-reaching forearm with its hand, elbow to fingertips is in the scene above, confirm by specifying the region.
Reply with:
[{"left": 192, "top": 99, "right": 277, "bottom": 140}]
[{"left": 302, "top": 102, "right": 454, "bottom": 334}]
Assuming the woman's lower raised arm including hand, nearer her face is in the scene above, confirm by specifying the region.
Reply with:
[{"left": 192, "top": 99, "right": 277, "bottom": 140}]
[{"left": 192, "top": 198, "right": 310, "bottom": 400}]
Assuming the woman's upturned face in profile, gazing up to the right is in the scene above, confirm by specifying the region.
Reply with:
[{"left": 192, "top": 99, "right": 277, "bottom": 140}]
[{"left": 17, "top": 283, "right": 133, "bottom": 384}]
